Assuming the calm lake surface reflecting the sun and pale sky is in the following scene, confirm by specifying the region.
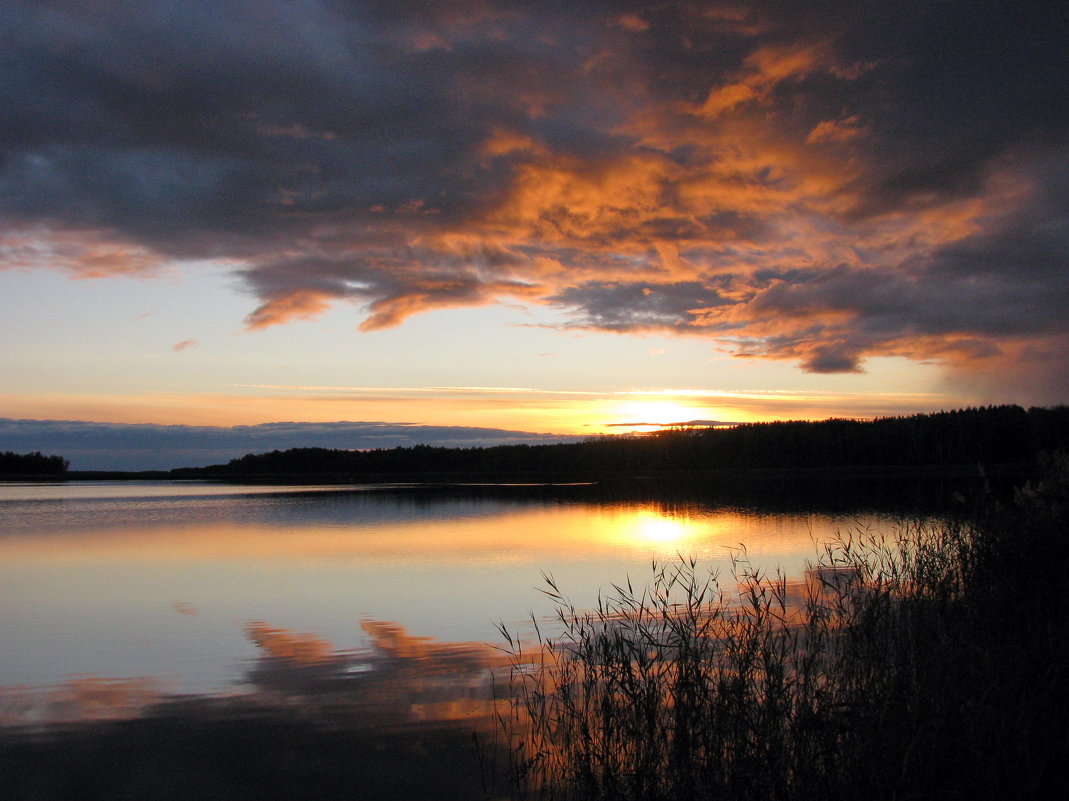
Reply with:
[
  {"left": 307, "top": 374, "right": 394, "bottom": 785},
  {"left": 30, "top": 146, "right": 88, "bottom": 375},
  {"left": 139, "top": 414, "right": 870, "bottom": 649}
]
[{"left": 0, "top": 482, "right": 906, "bottom": 725}]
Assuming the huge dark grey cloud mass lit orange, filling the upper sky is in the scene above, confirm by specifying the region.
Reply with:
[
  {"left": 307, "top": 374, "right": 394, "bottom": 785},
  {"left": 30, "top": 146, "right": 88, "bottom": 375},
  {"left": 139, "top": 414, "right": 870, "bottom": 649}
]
[{"left": 6, "top": 0, "right": 1069, "bottom": 384}]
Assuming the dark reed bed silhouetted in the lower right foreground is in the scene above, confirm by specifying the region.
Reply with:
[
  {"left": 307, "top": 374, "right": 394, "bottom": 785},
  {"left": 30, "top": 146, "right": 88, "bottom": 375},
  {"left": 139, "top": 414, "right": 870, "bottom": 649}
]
[{"left": 501, "top": 468, "right": 1069, "bottom": 801}]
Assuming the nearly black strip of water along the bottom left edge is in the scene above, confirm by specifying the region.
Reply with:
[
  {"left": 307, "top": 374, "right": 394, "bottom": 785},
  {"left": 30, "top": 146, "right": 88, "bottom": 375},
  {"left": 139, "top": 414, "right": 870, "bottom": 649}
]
[{"left": 0, "top": 708, "right": 496, "bottom": 801}]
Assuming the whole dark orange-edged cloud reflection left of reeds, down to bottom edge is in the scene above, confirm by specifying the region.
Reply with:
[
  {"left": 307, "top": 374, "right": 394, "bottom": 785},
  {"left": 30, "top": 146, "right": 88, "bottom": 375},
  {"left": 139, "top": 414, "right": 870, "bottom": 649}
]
[{"left": 0, "top": 620, "right": 500, "bottom": 801}]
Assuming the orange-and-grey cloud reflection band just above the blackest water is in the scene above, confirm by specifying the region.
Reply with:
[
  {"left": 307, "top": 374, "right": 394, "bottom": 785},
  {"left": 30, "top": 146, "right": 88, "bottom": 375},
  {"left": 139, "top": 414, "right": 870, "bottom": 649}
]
[{"left": 0, "top": 620, "right": 509, "bottom": 727}]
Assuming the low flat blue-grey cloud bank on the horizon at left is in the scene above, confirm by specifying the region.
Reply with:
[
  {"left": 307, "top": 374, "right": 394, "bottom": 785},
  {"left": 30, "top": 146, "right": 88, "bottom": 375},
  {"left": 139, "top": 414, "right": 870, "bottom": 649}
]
[{"left": 0, "top": 418, "right": 574, "bottom": 471}]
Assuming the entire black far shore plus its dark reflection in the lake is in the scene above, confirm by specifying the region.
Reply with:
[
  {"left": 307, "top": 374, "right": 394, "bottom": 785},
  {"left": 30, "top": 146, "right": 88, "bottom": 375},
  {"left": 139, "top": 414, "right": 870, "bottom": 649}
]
[{"left": 6, "top": 405, "right": 1069, "bottom": 510}]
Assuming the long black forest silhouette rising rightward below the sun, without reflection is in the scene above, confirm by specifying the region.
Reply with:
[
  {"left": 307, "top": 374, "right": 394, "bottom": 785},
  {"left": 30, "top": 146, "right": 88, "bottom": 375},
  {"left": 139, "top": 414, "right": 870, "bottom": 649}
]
[{"left": 208, "top": 405, "right": 1069, "bottom": 477}]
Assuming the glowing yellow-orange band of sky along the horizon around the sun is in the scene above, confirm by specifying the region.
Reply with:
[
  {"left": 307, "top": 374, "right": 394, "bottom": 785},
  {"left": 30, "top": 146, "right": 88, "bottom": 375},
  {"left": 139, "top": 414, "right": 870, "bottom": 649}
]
[{"left": 0, "top": 384, "right": 948, "bottom": 437}]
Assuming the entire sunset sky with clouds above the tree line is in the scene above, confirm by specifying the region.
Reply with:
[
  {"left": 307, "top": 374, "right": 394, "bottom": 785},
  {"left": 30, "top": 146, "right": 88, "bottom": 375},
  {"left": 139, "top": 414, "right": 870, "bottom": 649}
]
[{"left": 0, "top": 0, "right": 1069, "bottom": 467}]
